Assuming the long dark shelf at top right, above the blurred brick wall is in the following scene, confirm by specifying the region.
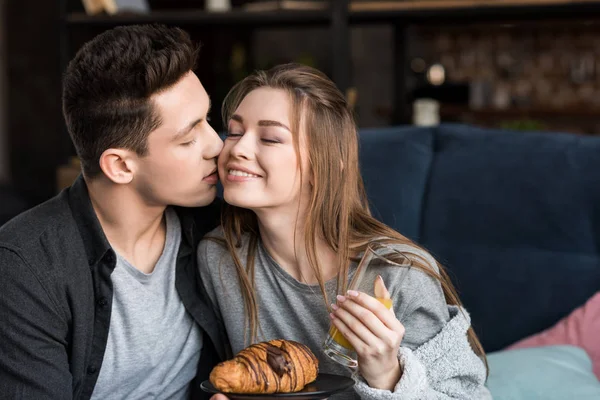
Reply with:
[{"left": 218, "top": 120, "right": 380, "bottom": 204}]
[{"left": 349, "top": 0, "right": 600, "bottom": 24}]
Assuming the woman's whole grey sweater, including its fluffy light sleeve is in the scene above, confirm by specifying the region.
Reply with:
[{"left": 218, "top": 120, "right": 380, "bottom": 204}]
[{"left": 198, "top": 228, "right": 491, "bottom": 400}]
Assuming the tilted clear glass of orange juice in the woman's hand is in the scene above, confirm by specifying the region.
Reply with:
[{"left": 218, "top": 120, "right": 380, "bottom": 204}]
[{"left": 323, "top": 242, "right": 411, "bottom": 368}]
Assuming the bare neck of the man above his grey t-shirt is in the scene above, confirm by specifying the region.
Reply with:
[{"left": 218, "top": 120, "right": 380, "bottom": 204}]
[{"left": 87, "top": 178, "right": 166, "bottom": 273}]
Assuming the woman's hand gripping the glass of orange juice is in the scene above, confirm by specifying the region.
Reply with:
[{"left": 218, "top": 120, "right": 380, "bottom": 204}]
[{"left": 330, "top": 278, "right": 404, "bottom": 390}]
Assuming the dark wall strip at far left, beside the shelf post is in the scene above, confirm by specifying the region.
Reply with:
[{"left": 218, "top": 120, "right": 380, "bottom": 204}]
[{"left": 5, "top": 0, "right": 63, "bottom": 203}]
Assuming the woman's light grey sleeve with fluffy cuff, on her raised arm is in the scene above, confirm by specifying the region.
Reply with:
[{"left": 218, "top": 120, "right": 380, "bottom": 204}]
[{"left": 354, "top": 247, "right": 491, "bottom": 400}]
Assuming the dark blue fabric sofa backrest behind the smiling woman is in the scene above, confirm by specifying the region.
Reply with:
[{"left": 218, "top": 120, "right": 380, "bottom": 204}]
[{"left": 360, "top": 124, "right": 600, "bottom": 352}]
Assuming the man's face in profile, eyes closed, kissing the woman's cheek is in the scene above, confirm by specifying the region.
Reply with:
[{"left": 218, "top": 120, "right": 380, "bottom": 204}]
[{"left": 132, "top": 72, "right": 223, "bottom": 207}]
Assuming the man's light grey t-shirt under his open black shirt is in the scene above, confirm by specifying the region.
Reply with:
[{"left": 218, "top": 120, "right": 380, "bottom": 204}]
[{"left": 92, "top": 209, "right": 202, "bottom": 400}]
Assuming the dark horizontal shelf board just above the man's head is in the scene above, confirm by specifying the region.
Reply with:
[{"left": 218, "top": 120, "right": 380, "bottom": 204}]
[{"left": 65, "top": 10, "right": 331, "bottom": 27}]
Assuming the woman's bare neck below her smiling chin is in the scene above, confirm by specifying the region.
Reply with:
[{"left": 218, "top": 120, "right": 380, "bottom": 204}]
[{"left": 257, "top": 211, "right": 337, "bottom": 285}]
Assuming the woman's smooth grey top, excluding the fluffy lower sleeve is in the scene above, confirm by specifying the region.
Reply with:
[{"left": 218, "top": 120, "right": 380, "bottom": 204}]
[{"left": 198, "top": 228, "right": 450, "bottom": 400}]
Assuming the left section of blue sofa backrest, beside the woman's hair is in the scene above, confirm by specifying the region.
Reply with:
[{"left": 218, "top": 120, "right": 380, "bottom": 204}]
[{"left": 359, "top": 127, "right": 433, "bottom": 240}]
